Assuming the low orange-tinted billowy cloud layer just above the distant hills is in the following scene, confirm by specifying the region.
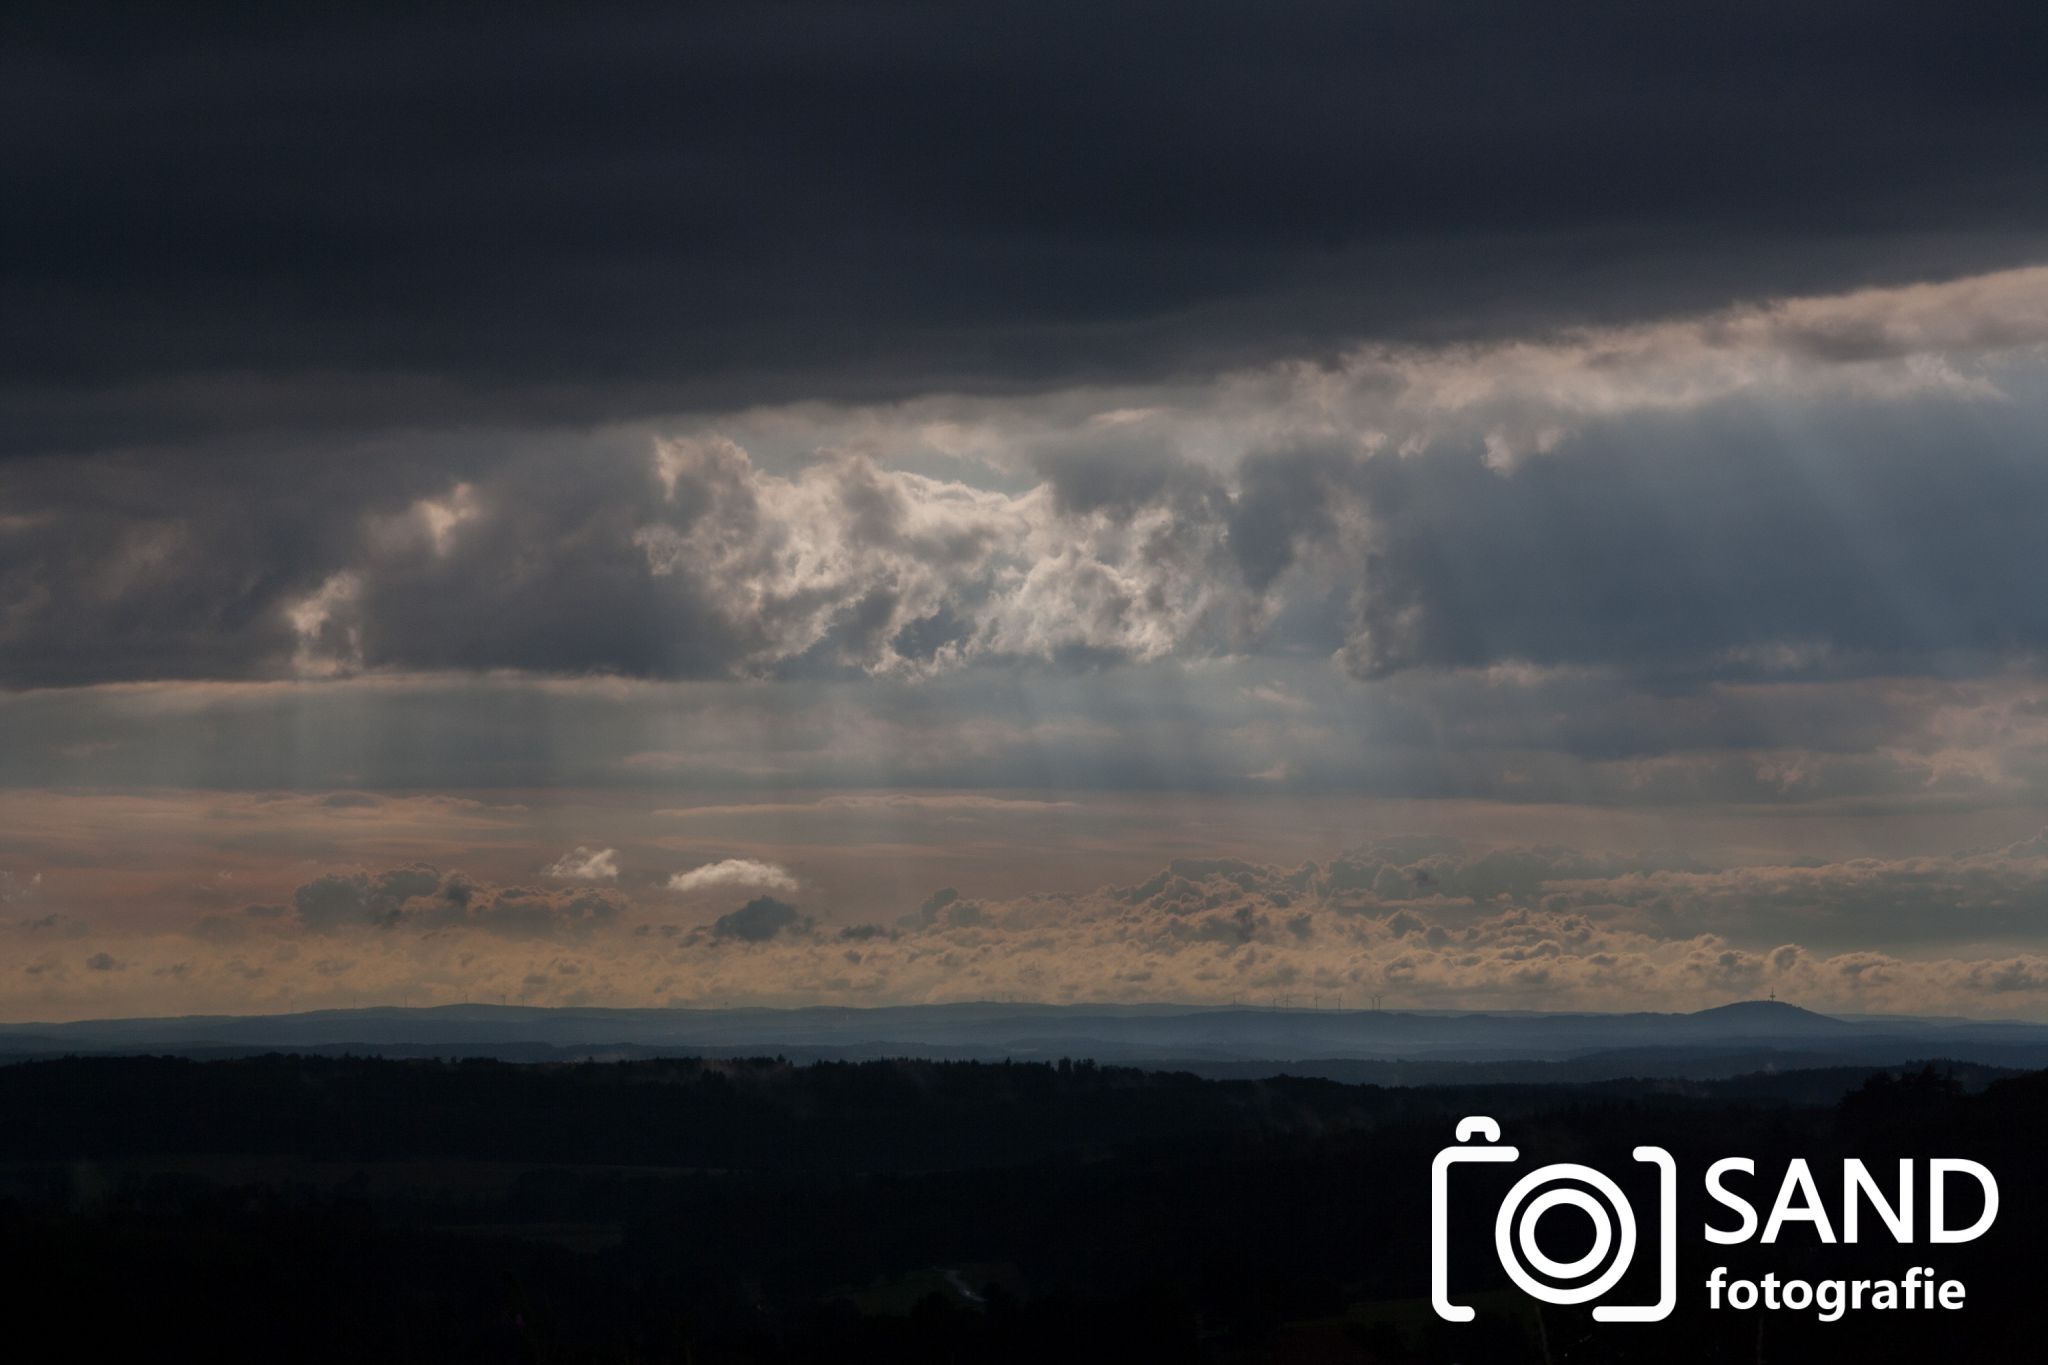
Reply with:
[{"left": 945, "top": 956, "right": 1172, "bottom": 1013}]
[{"left": 19, "top": 833, "right": 2048, "bottom": 1017}]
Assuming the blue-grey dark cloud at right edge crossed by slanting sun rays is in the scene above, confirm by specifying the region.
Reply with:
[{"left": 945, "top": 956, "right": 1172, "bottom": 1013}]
[{"left": 1346, "top": 401, "right": 2048, "bottom": 677}]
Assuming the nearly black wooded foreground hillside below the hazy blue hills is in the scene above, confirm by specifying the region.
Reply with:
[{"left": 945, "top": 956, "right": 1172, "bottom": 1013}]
[{"left": 0, "top": 1056, "right": 2048, "bottom": 1363}]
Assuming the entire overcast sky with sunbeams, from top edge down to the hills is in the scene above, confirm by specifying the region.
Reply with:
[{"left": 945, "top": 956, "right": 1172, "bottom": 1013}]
[{"left": 0, "top": 0, "right": 2048, "bottom": 1019}]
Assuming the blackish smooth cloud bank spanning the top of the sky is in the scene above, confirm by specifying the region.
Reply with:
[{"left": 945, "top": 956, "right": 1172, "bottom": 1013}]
[{"left": 0, "top": 0, "right": 2048, "bottom": 450}]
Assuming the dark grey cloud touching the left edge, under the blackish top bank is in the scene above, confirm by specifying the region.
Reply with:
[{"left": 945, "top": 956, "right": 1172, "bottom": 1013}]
[{"left": 0, "top": 428, "right": 593, "bottom": 686}]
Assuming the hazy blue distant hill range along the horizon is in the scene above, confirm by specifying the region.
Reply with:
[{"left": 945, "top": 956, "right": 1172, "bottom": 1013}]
[{"left": 0, "top": 1001, "right": 2048, "bottom": 1085}]
